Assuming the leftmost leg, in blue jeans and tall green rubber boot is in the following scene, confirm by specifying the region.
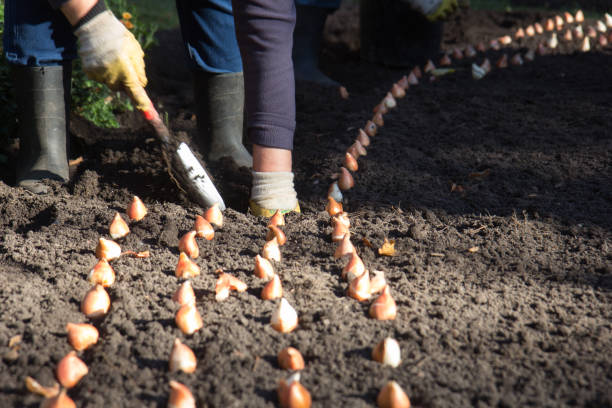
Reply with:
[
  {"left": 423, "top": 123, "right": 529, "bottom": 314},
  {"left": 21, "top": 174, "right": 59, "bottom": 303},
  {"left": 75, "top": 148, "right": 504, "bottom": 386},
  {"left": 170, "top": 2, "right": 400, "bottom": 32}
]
[{"left": 4, "top": 0, "right": 76, "bottom": 194}]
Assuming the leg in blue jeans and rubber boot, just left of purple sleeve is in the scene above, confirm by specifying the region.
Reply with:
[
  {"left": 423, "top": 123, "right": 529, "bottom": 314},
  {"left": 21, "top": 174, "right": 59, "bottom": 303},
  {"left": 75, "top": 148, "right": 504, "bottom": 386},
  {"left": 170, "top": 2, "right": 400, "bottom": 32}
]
[{"left": 176, "top": 0, "right": 252, "bottom": 167}]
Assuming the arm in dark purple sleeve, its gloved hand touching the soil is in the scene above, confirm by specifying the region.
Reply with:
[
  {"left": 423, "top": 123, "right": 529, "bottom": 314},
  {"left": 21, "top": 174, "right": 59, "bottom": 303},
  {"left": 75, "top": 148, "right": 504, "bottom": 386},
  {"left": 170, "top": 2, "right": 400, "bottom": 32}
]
[{"left": 233, "top": 0, "right": 299, "bottom": 216}]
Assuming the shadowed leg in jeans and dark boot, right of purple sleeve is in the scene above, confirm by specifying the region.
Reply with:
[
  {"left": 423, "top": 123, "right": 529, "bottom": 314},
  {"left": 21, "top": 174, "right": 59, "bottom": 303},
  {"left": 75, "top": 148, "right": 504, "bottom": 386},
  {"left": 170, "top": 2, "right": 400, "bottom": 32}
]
[{"left": 293, "top": 0, "right": 340, "bottom": 86}]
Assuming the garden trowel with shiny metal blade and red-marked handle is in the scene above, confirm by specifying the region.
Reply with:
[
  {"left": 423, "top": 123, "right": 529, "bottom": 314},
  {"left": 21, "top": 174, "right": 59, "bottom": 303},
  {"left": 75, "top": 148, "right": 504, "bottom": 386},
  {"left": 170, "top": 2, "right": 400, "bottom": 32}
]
[{"left": 142, "top": 94, "right": 225, "bottom": 210}]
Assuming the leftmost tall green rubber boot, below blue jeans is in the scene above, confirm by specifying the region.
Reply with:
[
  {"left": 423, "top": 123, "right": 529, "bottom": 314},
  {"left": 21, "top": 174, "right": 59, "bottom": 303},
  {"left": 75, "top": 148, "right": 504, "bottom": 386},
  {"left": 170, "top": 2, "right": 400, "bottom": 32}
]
[{"left": 12, "top": 63, "right": 72, "bottom": 194}]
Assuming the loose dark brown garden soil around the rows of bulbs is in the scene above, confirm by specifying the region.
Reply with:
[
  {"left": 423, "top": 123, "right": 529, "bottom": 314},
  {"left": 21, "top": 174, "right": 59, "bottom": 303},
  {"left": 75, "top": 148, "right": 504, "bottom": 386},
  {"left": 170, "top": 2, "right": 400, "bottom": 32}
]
[{"left": 0, "top": 3, "right": 612, "bottom": 407}]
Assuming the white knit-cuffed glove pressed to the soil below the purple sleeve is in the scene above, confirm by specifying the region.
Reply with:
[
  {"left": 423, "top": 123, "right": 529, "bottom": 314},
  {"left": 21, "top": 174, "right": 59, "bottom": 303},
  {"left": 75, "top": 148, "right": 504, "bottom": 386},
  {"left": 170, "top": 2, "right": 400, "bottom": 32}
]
[{"left": 249, "top": 171, "right": 300, "bottom": 217}]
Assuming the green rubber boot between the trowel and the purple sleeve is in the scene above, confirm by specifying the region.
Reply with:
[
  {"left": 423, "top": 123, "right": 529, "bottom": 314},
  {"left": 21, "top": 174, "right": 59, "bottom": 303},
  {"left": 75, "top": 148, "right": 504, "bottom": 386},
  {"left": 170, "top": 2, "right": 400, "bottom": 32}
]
[{"left": 194, "top": 71, "right": 253, "bottom": 167}]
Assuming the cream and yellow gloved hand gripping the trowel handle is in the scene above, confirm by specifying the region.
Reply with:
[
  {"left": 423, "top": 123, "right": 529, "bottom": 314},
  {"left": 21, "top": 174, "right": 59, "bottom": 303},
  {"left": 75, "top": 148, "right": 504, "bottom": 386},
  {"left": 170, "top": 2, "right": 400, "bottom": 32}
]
[{"left": 74, "top": 11, "right": 150, "bottom": 111}]
